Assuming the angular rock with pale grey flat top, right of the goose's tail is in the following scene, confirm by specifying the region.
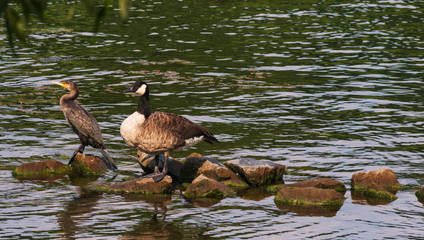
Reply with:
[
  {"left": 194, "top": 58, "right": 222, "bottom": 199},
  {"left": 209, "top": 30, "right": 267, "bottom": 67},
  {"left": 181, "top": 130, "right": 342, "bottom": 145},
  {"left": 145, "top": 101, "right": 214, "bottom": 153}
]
[{"left": 224, "top": 159, "right": 286, "bottom": 186}]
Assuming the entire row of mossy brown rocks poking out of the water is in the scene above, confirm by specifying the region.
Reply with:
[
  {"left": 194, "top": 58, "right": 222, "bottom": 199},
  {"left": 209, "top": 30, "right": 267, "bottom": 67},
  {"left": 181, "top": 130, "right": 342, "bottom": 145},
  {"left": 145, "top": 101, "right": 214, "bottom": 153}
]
[{"left": 12, "top": 153, "right": 424, "bottom": 216}]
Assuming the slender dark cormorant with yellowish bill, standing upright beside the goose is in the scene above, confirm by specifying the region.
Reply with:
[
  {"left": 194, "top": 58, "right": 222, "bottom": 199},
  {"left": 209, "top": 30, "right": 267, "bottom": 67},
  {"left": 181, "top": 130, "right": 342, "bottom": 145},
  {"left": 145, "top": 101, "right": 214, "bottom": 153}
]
[{"left": 51, "top": 81, "right": 118, "bottom": 171}]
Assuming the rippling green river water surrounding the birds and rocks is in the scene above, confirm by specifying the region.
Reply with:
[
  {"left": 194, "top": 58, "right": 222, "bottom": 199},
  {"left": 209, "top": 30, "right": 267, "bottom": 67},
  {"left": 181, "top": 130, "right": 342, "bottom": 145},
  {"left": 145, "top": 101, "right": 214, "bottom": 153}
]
[{"left": 0, "top": 0, "right": 424, "bottom": 239}]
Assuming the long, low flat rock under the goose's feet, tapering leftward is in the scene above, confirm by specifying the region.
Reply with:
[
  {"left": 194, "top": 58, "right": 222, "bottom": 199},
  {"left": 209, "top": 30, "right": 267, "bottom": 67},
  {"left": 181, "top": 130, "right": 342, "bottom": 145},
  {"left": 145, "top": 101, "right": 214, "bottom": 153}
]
[{"left": 87, "top": 175, "right": 173, "bottom": 195}]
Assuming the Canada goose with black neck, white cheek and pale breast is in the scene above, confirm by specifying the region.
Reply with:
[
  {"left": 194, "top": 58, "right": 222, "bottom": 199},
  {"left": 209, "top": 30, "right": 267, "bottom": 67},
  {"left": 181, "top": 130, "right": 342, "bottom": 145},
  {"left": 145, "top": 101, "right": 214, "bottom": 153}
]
[{"left": 121, "top": 81, "right": 218, "bottom": 182}]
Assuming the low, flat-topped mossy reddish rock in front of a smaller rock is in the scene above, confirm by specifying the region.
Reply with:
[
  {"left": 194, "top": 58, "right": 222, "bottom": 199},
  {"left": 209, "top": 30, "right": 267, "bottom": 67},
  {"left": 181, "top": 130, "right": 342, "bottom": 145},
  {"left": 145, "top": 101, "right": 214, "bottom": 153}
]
[{"left": 274, "top": 187, "right": 344, "bottom": 210}]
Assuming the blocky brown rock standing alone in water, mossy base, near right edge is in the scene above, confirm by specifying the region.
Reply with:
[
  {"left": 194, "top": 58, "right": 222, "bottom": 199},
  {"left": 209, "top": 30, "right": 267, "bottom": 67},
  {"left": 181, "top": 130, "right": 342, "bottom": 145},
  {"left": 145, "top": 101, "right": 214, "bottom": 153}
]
[{"left": 351, "top": 168, "right": 401, "bottom": 201}]
